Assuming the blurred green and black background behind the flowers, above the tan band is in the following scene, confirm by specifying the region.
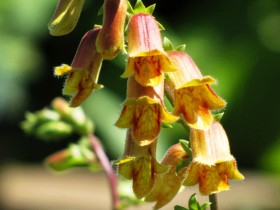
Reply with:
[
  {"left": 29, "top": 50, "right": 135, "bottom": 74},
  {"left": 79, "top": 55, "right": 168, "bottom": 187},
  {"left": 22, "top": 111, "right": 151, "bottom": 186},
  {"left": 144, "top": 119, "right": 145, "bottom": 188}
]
[{"left": 0, "top": 0, "right": 280, "bottom": 174}]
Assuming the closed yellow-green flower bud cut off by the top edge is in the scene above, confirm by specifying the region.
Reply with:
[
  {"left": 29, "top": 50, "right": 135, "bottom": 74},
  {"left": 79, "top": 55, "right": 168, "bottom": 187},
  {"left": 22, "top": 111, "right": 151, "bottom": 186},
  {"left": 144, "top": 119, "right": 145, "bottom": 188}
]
[{"left": 48, "top": 0, "right": 85, "bottom": 36}]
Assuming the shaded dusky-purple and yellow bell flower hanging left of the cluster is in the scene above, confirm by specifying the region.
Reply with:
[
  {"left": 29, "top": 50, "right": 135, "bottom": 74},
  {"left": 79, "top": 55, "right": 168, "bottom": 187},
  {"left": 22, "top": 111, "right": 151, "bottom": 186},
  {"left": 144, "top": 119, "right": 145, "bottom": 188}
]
[{"left": 55, "top": 28, "right": 103, "bottom": 107}]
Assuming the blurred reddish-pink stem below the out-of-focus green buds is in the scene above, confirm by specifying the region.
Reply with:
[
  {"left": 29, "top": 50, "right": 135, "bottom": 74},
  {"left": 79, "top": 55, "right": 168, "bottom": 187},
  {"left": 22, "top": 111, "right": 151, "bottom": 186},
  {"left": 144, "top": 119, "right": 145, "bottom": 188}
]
[{"left": 89, "top": 134, "right": 120, "bottom": 210}]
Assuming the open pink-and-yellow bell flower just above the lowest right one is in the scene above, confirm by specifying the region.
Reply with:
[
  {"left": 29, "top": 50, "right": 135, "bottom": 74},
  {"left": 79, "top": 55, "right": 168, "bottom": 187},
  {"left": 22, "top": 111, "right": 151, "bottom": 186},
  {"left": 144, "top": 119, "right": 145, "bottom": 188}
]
[{"left": 165, "top": 51, "right": 226, "bottom": 129}]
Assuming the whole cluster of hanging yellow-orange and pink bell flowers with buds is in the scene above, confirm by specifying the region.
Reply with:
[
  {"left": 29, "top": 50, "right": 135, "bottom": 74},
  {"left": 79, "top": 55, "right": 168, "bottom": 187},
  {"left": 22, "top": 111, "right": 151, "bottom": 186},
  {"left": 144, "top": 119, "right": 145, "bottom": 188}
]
[{"left": 49, "top": 0, "right": 244, "bottom": 208}]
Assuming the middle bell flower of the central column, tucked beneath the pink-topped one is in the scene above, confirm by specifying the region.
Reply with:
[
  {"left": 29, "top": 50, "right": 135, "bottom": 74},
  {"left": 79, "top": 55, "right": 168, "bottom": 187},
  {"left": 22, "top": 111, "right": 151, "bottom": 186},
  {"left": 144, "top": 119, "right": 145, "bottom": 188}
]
[{"left": 116, "top": 77, "right": 178, "bottom": 146}]
